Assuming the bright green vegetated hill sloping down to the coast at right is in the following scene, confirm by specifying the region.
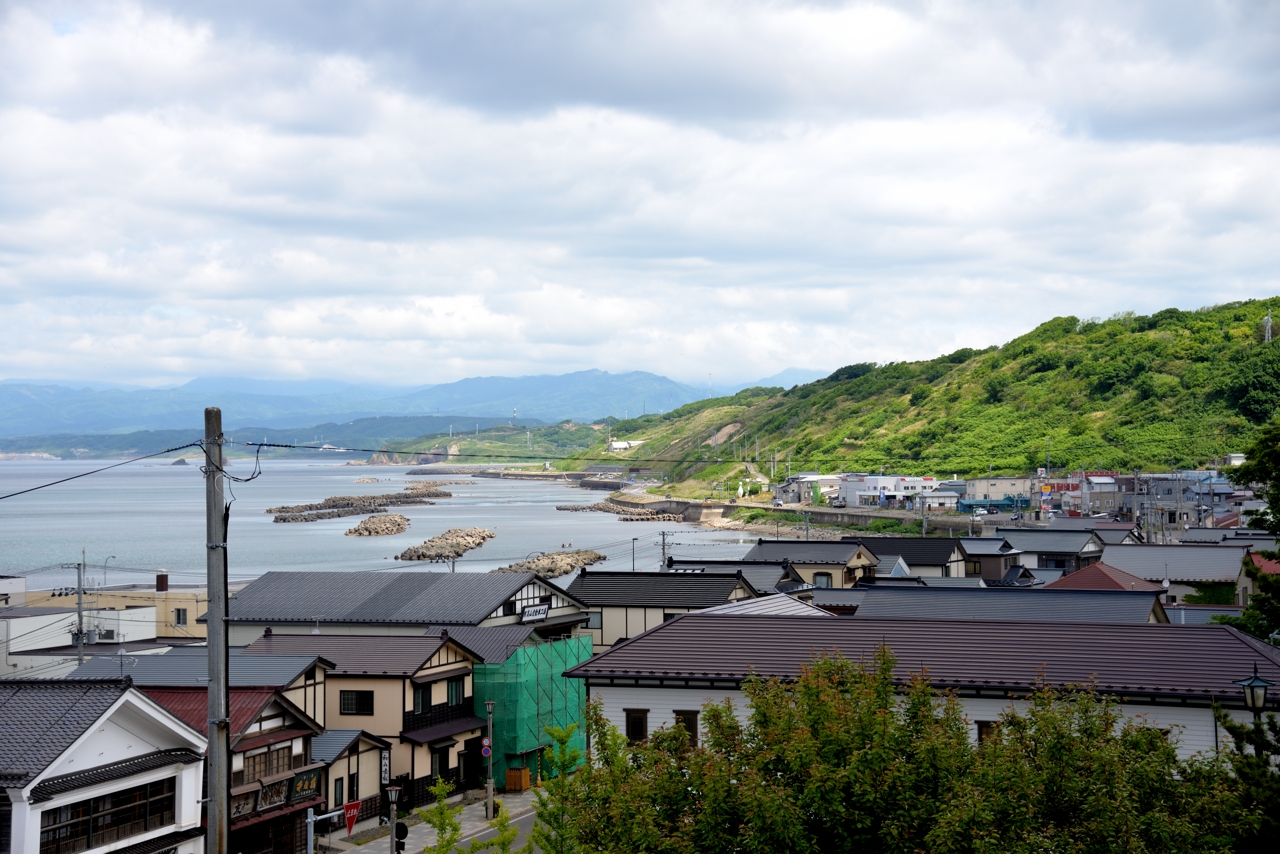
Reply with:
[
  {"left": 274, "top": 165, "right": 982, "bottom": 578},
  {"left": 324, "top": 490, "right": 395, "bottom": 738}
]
[{"left": 578, "top": 297, "right": 1280, "bottom": 479}]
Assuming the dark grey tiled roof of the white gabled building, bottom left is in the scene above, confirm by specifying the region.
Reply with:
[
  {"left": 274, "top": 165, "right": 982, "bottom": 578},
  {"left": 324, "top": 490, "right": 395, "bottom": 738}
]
[{"left": 0, "top": 679, "right": 129, "bottom": 789}]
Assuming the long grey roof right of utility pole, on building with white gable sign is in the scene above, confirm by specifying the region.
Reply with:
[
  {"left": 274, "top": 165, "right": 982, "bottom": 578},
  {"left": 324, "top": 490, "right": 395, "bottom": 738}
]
[{"left": 230, "top": 571, "right": 536, "bottom": 626}]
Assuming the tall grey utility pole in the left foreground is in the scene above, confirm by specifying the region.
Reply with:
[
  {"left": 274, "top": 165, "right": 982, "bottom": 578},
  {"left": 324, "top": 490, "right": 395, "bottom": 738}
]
[{"left": 204, "top": 406, "right": 232, "bottom": 854}]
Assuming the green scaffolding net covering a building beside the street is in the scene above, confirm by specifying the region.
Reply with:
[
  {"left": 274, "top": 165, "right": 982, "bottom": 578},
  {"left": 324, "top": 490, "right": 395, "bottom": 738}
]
[{"left": 472, "top": 636, "right": 591, "bottom": 786}]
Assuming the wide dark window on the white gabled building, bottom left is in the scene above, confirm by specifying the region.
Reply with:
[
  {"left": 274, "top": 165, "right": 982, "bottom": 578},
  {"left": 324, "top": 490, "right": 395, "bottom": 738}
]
[{"left": 40, "top": 777, "right": 177, "bottom": 854}]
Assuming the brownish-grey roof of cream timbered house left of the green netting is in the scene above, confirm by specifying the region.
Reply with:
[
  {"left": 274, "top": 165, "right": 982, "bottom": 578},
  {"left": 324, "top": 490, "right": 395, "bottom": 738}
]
[{"left": 241, "top": 634, "right": 444, "bottom": 676}]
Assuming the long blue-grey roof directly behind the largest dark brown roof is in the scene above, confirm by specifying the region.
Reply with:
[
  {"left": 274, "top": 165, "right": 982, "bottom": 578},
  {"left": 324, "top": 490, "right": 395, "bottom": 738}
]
[{"left": 858, "top": 585, "right": 1157, "bottom": 622}]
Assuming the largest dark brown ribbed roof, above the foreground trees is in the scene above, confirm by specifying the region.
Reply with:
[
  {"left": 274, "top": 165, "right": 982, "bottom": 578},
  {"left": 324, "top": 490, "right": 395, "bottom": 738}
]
[{"left": 566, "top": 612, "right": 1280, "bottom": 705}]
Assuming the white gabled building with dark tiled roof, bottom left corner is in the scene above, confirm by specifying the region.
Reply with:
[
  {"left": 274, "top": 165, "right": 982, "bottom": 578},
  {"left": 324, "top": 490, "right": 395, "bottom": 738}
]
[{"left": 0, "top": 679, "right": 205, "bottom": 854}]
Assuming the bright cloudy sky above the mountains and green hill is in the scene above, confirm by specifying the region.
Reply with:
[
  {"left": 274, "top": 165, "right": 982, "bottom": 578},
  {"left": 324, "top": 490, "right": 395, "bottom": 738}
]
[{"left": 0, "top": 0, "right": 1280, "bottom": 384}]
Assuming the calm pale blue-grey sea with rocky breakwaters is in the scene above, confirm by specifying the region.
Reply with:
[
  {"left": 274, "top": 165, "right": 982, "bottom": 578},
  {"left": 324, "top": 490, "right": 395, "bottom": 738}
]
[{"left": 0, "top": 460, "right": 754, "bottom": 589}]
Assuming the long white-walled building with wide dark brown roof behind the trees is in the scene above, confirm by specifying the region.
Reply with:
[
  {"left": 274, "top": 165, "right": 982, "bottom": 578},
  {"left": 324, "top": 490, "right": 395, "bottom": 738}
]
[{"left": 568, "top": 614, "right": 1280, "bottom": 757}]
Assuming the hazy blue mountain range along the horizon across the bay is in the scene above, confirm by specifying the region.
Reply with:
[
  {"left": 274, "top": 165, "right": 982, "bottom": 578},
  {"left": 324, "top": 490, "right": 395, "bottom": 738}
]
[{"left": 0, "top": 369, "right": 820, "bottom": 437}]
